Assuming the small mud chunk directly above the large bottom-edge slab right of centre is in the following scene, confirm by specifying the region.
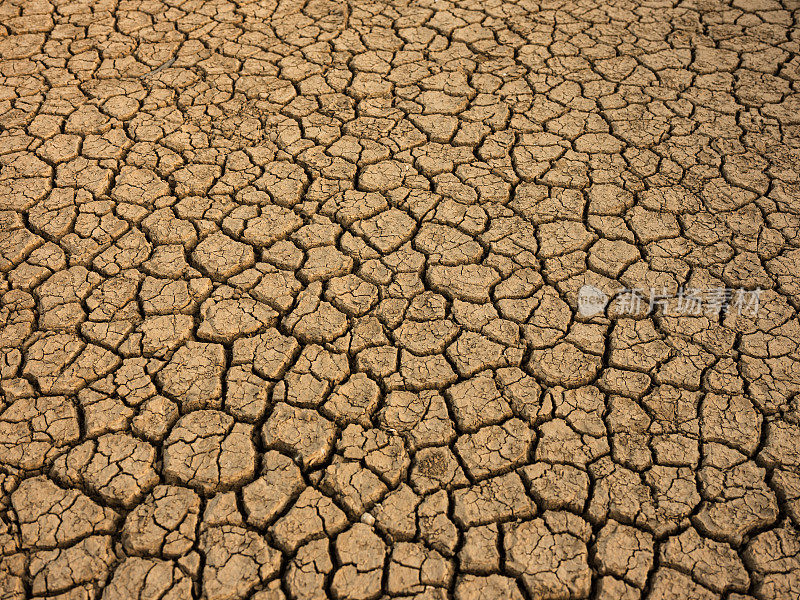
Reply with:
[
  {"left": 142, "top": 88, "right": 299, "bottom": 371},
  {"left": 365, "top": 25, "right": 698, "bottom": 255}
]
[{"left": 520, "top": 462, "right": 589, "bottom": 512}]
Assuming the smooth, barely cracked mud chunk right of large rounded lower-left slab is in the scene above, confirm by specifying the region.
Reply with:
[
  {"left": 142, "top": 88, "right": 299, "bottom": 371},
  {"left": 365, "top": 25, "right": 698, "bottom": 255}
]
[{"left": 261, "top": 403, "right": 336, "bottom": 468}]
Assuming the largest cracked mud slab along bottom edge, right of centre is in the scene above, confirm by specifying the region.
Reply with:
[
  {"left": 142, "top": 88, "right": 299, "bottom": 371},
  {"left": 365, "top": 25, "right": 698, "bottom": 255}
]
[{"left": 503, "top": 512, "right": 591, "bottom": 600}]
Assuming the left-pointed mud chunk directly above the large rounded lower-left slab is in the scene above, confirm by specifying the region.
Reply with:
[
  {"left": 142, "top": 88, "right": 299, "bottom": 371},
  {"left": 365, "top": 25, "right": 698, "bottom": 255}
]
[{"left": 156, "top": 342, "right": 226, "bottom": 410}]
